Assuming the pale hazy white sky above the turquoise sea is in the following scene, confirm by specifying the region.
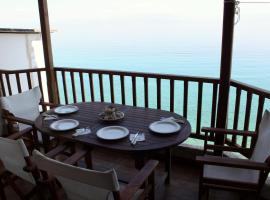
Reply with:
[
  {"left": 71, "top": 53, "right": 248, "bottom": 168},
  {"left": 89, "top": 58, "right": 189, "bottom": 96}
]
[{"left": 0, "top": 0, "right": 270, "bottom": 49}]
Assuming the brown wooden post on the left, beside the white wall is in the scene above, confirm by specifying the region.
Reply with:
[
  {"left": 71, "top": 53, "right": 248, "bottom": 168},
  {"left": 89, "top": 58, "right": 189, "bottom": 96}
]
[{"left": 38, "top": 0, "right": 58, "bottom": 103}]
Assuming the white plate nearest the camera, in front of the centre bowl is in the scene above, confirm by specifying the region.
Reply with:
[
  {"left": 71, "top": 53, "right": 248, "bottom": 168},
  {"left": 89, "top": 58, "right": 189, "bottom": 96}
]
[{"left": 97, "top": 126, "right": 129, "bottom": 140}]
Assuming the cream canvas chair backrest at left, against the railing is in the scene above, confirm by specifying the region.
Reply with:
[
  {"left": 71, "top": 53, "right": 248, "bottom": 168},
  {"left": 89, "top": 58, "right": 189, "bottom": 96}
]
[{"left": 0, "top": 86, "right": 41, "bottom": 121}]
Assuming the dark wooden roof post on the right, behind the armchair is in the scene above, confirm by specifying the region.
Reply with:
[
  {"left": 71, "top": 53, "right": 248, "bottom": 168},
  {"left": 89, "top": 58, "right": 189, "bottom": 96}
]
[{"left": 215, "top": 0, "right": 236, "bottom": 155}]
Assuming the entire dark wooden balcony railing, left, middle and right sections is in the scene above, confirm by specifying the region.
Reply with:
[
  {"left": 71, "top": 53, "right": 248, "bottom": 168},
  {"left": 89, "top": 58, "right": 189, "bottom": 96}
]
[{"left": 0, "top": 67, "right": 270, "bottom": 145}]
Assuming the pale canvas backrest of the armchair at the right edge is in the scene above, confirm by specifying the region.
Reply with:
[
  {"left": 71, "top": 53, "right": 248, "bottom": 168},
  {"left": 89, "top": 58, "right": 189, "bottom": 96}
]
[{"left": 250, "top": 110, "right": 270, "bottom": 162}]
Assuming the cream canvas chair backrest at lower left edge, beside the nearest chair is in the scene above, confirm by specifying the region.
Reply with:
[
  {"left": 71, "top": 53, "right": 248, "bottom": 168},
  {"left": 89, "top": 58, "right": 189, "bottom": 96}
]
[{"left": 0, "top": 137, "right": 36, "bottom": 184}]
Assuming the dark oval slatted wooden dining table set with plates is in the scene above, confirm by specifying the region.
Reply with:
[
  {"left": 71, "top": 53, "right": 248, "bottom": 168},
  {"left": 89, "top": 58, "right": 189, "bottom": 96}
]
[{"left": 35, "top": 102, "right": 191, "bottom": 183}]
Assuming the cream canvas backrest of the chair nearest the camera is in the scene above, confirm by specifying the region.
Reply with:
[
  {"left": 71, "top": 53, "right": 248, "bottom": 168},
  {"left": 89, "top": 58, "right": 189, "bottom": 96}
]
[{"left": 33, "top": 150, "right": 120, "bottom": 200}]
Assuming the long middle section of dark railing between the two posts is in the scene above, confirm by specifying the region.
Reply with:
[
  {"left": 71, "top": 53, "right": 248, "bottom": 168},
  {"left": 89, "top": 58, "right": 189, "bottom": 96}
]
[{"left": 55, "top": 68, "right": 218, "bottom": 138}]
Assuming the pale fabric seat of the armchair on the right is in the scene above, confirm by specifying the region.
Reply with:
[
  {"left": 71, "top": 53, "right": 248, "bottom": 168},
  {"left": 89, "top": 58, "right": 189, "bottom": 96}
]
[{"left": 203, "top": 165, "right": 259, "bottom": 184}]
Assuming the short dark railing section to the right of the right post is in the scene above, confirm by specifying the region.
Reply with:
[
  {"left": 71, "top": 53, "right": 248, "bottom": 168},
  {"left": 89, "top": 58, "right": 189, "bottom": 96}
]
[{"left": 226, "top": 80, "right": 270, "bottom": 152}]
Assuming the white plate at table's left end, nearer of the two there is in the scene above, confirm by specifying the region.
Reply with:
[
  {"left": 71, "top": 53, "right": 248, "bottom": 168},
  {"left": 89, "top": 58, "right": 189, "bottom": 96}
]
[{"left": 50, "top": 119, "right": 79, "bottom": 131}]
